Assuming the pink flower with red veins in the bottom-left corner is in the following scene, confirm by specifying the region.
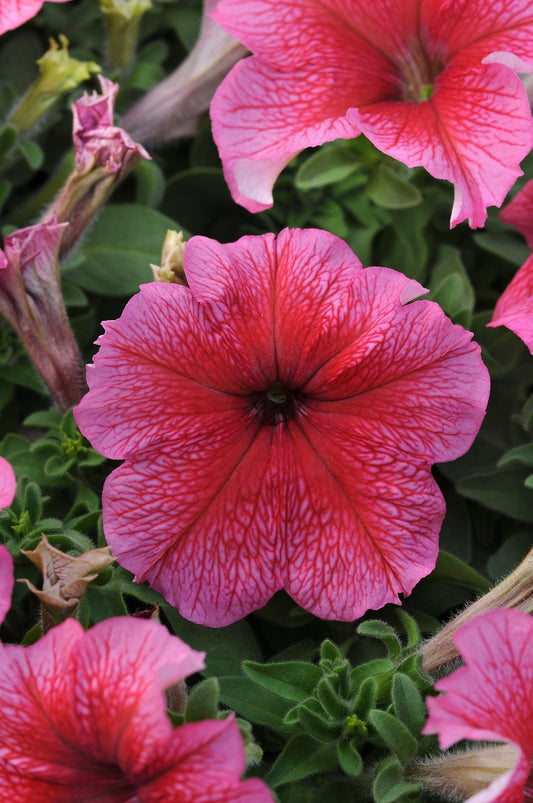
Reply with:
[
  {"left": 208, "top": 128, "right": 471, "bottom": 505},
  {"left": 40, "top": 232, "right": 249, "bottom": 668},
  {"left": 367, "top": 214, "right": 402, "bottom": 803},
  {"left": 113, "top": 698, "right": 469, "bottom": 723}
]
[{"left": 0, "top": 560, "right": 272, "bottom": 803}]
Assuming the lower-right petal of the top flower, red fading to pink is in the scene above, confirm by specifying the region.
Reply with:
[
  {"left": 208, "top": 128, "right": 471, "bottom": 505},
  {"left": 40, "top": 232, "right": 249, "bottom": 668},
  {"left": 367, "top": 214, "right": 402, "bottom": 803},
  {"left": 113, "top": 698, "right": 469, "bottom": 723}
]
[{"left": 347, "top": 64, "right": 533, "bottom": 228}]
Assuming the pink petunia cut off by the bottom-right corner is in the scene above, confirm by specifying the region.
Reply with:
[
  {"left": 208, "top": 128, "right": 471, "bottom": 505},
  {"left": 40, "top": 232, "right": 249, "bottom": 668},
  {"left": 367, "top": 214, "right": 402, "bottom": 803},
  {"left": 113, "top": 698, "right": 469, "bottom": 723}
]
[{"left": 424, "top": 610, "right": 533, "bottom": 803}]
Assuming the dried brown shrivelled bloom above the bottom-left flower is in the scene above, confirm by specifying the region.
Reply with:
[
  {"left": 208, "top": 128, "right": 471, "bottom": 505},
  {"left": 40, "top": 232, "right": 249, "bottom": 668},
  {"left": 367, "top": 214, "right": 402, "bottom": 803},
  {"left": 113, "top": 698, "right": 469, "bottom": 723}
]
[{"left": 20, "top": 535, "right": 115, "bottom": 619}]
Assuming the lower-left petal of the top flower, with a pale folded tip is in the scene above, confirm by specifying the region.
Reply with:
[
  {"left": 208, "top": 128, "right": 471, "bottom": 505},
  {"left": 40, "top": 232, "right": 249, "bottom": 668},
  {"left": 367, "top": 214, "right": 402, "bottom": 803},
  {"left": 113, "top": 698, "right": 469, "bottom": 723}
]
[{"left": 211, "top": 56, "right": 359, "bottom": 212}]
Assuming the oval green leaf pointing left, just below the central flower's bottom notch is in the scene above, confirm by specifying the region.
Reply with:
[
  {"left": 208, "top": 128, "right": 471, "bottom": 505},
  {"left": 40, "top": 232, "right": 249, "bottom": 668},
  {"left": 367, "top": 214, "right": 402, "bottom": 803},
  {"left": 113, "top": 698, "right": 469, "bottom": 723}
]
[{"left": 242, "top": 661, "right": 322, "bottom": 703}]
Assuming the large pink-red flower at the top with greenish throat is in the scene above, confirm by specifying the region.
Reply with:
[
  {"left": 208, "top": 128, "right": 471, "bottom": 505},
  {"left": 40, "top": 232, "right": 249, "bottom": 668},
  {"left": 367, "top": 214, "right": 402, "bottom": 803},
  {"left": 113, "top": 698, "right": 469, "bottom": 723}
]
[{"left": 211, "top": 0, "right": 533, "bottom": 227}]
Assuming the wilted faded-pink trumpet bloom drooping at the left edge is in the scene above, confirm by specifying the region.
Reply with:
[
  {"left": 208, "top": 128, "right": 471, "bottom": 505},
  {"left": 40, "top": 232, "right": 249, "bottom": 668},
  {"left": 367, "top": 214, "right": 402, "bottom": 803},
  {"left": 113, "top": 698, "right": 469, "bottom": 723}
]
[{"left": 0, "top": 216, "right": 85, "bottom": 411}]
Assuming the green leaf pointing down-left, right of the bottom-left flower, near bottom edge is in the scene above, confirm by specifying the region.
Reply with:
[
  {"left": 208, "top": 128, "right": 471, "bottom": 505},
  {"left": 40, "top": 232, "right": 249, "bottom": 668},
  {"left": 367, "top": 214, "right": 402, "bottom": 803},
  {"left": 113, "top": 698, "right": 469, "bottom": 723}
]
[{"left": 265, "top": 734, "right": 337, "bottom": 789}]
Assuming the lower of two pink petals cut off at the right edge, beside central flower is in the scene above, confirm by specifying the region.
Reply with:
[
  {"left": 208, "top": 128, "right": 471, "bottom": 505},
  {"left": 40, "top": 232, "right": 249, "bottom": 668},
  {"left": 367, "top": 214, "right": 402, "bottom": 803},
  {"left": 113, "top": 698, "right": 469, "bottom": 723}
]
[{"left": 487, "top": 254, "right": 533, "bottom": 354}]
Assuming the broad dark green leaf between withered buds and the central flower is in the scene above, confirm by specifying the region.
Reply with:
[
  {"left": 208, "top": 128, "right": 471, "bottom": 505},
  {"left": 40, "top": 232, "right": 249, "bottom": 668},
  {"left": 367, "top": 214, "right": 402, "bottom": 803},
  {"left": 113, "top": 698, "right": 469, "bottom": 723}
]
[{"left": 65, "top": 204, "right": 188, "bottom": 297}]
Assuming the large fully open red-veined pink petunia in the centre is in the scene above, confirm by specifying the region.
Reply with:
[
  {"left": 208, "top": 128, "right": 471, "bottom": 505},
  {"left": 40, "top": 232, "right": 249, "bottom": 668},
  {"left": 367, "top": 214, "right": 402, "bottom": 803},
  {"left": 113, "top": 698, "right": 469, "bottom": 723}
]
[{"left": 75, "top": 229, "right": 489, "bottom": 626}]
